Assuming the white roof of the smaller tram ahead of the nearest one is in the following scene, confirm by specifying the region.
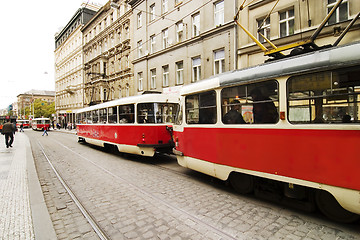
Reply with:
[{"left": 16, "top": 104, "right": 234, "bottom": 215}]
[{"left": 77, "top": 93, "right": 179, "bottom": 113}]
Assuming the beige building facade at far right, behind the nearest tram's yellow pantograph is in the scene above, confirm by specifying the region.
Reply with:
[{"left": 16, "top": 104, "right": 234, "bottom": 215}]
[{"left": 237, "top": 0, "right": 360, "bottom": 68}]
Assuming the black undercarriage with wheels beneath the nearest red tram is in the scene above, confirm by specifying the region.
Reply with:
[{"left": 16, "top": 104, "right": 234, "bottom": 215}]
[{"left": 228, "top": 172, "right": 360, "bottom": 223}]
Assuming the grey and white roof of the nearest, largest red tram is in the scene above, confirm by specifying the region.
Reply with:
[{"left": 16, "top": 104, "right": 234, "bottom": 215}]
[{"left": 180, "top": 42, "right": 360, "bottom": 95}]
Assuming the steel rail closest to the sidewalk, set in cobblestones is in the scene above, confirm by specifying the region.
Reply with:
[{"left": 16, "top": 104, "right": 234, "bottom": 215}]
[{"left": 37, "top": 141, "right": 111, "bottom": 240}]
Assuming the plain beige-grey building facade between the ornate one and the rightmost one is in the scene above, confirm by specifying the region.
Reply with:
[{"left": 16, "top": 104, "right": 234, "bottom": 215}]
[{"left": 129, "top": 0, "right": 237, "bottom": 94}]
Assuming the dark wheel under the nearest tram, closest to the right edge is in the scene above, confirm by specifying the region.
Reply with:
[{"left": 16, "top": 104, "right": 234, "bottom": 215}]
[{"left": 315, "top": 190, "right": 360, "bottom": 223}]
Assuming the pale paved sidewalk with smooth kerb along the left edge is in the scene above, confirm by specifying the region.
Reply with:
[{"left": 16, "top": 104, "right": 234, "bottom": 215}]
[{"left": 0, "top": 132, "right": 56, "bottom": 239}]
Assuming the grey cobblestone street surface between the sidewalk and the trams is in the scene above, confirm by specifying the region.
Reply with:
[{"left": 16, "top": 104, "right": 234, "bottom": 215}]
[{"left": 25, "top": 132, "right": 360, "bottom": 239}]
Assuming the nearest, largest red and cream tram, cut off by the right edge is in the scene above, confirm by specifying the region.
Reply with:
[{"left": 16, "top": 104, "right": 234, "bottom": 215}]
[{"left": 173, "top": 42, "right": 360, "bottom": 222}]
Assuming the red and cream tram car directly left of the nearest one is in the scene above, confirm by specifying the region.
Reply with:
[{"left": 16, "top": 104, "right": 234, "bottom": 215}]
[{"left": 76, "top": 93, "right": 179, "bottom": 156}]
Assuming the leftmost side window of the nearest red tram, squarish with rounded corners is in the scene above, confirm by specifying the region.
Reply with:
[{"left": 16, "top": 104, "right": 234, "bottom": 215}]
[{"left": 185, "top": 91, "right": 216, "bottom": 124}]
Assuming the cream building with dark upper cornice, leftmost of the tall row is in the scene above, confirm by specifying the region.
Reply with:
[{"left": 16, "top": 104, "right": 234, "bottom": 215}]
[{"left": 55, "top": 4, "right": 100, "bottom": 126}]
